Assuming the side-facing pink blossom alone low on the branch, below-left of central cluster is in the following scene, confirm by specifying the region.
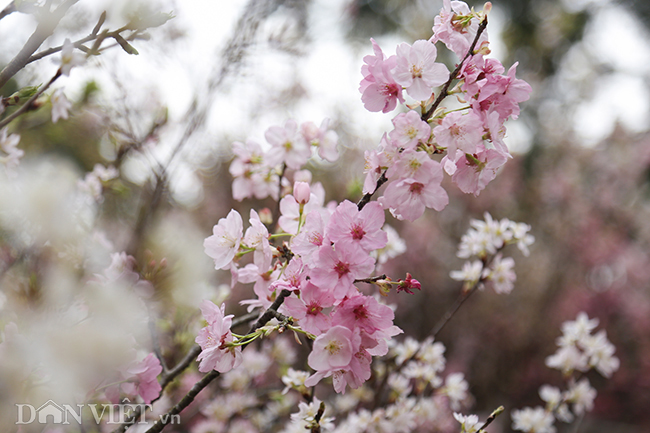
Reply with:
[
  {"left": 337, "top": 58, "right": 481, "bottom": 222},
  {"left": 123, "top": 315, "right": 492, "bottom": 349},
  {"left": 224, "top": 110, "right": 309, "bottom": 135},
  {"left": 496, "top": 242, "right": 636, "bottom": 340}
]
[{"left": 195, "top": 300, "right": 242, "bottom": 373}]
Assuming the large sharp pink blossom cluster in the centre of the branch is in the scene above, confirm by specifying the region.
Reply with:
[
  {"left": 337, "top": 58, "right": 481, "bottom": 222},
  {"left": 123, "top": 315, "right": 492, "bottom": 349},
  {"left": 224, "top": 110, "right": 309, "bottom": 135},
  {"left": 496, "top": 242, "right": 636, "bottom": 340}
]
[{"left": 204, "top": 186, "right": 404, "bottom": 392}]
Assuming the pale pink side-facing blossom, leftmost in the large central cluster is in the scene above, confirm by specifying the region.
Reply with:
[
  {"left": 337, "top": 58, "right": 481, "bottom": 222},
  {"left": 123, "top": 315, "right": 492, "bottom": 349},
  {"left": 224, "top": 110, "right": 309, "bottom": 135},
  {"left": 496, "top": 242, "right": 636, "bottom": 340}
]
[{"left": 203, "top": 209, "right": 244, "bottom": 269}]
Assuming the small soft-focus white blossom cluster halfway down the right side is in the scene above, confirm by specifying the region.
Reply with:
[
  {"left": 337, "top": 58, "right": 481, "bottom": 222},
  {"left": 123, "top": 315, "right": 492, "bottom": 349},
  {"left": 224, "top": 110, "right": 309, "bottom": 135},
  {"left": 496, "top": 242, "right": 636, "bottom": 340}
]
[{"left": 450, "top": 212, "right": 535, "bottom": 293}]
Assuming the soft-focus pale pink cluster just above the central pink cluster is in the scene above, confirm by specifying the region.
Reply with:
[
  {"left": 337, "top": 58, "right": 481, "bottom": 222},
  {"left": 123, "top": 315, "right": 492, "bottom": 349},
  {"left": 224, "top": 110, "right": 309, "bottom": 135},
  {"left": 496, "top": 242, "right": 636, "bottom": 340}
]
[{"left": 230, "top": 119, "right": 339, "bottom": 201}]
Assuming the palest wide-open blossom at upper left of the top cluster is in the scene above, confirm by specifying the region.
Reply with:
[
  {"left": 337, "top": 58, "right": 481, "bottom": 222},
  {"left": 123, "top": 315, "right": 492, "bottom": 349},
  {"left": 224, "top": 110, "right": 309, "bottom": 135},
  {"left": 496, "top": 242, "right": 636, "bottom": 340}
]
[{"left": 394, "top": 40, "right": 449, "bottom": 101}]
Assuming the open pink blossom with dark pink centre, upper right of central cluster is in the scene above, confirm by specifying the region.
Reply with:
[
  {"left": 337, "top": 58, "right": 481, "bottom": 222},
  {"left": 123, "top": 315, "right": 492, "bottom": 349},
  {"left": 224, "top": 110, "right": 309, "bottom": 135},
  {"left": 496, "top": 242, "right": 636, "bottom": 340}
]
[{"left": 327, "top": 200, "right": 388, "bottom": 252}]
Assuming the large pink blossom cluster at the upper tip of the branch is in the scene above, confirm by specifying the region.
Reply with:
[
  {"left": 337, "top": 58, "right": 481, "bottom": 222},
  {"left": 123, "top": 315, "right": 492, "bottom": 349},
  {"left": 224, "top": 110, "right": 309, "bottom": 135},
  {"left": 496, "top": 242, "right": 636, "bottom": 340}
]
[{"left": 359, "top": 0, "right": 532, "bottom": 221}]
